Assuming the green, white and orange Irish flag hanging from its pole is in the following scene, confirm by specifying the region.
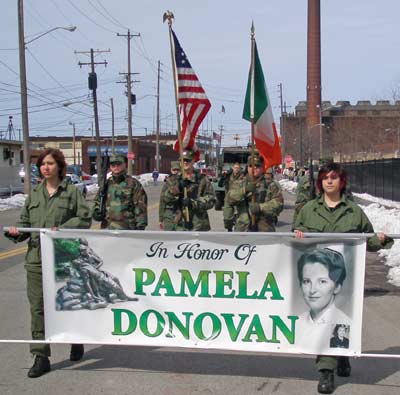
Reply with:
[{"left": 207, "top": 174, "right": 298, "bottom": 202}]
[{"left": 243, "top": 42, "right": 282, "bottom": 169}]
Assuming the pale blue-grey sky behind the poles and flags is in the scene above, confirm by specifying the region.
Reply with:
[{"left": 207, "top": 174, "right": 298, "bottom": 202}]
[{"left": 0, "top": 0, "right": 400, "bottom": 145}]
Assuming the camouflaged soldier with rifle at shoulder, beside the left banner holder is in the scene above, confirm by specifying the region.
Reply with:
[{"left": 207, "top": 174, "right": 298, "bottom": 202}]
[{"left": 92, "top": 155, "right": 147, "bottom": 230}]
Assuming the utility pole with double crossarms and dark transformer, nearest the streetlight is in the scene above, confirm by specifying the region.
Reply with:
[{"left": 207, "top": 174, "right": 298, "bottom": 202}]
[{"left": 75, "top": 48, "right": 110, "bottom": 185}]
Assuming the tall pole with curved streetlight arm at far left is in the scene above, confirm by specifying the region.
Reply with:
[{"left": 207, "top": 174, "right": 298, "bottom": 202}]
[{"left": 18, "top": 0, "right": 76, "bottom": 194}]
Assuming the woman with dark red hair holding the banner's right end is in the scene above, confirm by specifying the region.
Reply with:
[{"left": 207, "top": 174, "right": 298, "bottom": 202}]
[{"left": 293, "top": 162, "right": 393, "bottom": 394}]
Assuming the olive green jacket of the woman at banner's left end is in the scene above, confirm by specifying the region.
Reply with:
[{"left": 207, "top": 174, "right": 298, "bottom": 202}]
[{"left": 6, "top": 180, "right": 91, "bottom": 272}]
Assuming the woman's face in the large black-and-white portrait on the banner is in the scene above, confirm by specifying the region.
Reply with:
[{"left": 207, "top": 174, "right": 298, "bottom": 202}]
[{"left": 301, "top": 263, "right": 341, "bottom": 317}]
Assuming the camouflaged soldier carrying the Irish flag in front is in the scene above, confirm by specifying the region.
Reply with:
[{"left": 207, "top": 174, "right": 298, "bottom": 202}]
[{"left": 231, "top": 155, "right": 283, "bottom": 232}]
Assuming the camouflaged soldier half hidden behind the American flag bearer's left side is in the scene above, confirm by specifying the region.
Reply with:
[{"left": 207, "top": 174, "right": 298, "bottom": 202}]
[{"left": 158, "top": 161, "right": 181, "bottom": 230}]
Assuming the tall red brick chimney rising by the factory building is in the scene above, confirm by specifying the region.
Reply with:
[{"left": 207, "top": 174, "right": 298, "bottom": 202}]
[{"left": 306, "top": 0, "right": 321, "bottom": 152}]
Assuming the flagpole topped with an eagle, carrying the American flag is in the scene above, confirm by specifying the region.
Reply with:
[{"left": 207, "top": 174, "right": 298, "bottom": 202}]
[{"left": 163, "top": 10, "right": 189, "bottom": 223}]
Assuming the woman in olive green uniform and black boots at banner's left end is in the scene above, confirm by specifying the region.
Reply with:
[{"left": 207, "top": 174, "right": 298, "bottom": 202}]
[{"left": 6, "top": 148, "right": 91, "bottom": 377}]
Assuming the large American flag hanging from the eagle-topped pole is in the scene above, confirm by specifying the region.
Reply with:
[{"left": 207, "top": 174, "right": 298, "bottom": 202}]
[{"left": 171, "top": 30, "right": 211, "bottom": 158}]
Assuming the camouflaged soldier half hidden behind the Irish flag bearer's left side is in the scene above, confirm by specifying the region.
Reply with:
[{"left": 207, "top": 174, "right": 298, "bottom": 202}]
[{"left": 218, "top": 162, "right": 244, "bottom": 232}]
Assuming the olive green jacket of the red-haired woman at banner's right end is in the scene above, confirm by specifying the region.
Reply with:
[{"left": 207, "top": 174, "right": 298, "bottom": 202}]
[{"left": 293, "top": 195, "right": 393, "bottom": 251}]
